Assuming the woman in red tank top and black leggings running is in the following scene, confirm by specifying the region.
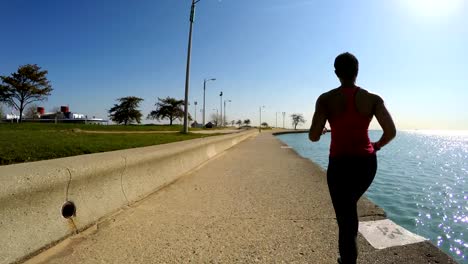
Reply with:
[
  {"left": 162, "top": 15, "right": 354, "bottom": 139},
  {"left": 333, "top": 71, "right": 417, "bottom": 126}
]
[{"left": 309, "top": 52, "right": 396, "bottom": 264}]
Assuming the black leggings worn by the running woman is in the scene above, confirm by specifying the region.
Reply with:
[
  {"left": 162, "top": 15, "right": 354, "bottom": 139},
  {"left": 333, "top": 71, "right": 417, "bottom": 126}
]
[{"left": 327, "top": 155, "right": 377, "bottom": 264}]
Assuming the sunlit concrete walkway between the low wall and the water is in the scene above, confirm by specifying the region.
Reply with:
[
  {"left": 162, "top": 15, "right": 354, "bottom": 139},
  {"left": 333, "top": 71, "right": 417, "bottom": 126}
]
[{"left": 28, "top": 133, "right": 454, "bottom": 264}]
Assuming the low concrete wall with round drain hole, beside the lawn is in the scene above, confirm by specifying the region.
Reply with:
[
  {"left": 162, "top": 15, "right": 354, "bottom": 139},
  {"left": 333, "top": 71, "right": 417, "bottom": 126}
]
[{"left": 0, "top": 130, "right": 257, "bottom": 263}]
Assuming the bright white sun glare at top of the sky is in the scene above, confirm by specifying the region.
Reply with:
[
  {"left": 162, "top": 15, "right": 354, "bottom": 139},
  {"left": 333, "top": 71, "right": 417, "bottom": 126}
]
[{"left": 399, "top": 0, "right": 464, "bottom": 18}]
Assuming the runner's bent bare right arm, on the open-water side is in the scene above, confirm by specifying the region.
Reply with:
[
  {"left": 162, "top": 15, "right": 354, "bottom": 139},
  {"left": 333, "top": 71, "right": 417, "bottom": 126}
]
[{"left": 374, "top": 96, "right": 396, "bottom": 150}]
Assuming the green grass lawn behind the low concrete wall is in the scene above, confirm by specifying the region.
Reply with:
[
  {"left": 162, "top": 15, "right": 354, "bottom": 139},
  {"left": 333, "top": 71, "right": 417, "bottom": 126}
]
[{"left": 0, "top": 123, "right": 217, "bottom": 165}]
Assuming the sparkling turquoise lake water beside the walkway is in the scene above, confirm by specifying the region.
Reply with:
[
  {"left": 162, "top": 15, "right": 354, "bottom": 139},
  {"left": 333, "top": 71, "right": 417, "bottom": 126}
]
[{"left": 278, "top": 131, "right": 468, "bottom": 263}]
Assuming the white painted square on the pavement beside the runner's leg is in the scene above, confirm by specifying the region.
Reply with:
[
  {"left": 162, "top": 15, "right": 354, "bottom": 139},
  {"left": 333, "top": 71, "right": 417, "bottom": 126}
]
[{"left": 359, "top": 219, "right": 427, "bottom": 249}]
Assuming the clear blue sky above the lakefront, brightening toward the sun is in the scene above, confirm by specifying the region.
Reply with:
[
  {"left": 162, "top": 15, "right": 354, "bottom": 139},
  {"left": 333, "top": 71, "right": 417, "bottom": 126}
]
[{"left": 0, "top": 0, "right": 468, "bottom": 130}]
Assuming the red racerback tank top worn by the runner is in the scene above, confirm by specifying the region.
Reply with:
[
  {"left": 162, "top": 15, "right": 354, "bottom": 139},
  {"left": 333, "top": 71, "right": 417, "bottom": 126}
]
[{"left": 328, "top": 87, "right": 374, "bottom": 157}]
